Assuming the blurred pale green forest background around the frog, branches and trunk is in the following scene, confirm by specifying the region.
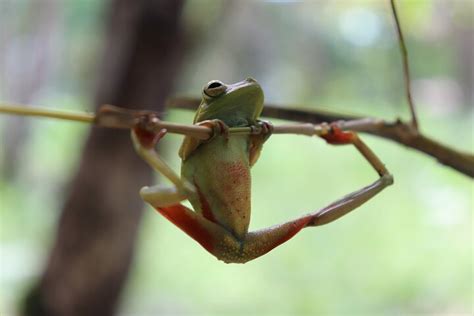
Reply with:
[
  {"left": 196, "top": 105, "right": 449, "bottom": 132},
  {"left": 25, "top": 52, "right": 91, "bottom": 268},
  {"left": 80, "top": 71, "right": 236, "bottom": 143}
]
[{"left": 0, "top": 0, "right": 474, "bottom": 315}]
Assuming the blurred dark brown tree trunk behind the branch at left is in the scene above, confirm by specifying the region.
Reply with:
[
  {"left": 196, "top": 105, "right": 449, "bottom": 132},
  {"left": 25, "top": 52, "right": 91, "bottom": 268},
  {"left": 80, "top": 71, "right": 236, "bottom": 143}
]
[{"left": 23, "top": 0, "right": 183, "bottom": 316}]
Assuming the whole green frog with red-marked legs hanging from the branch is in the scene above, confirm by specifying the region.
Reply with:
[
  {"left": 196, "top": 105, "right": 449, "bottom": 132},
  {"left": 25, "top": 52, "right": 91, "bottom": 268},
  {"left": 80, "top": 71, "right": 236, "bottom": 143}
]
[{"left": 132, "top": 78, "right": 393, "bottom": 263}]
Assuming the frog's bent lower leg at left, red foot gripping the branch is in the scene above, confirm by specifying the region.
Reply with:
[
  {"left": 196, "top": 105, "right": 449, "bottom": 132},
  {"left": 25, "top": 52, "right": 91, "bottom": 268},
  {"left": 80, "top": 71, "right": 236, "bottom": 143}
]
[{"left": 132, "top": 126, "right": 195, "bottom": 206}]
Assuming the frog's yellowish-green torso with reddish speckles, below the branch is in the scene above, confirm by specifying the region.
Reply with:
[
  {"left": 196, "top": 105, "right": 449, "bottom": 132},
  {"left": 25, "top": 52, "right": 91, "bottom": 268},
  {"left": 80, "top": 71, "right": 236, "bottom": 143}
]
[{"left": 181, "top": 136, "right": 251, "bottom": 237}]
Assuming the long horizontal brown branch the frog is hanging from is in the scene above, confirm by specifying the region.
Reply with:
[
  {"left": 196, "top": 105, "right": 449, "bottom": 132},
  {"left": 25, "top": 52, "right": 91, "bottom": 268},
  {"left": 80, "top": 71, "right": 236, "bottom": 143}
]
[{"left": 0, "top": 98, "right": 474, "bottom": 178}]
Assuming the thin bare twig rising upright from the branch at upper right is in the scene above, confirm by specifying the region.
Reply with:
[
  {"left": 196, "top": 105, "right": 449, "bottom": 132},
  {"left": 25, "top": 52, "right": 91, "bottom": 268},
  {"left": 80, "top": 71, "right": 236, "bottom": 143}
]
[{"left": 390, "top": 0, "right": 418, "bottom": 130}]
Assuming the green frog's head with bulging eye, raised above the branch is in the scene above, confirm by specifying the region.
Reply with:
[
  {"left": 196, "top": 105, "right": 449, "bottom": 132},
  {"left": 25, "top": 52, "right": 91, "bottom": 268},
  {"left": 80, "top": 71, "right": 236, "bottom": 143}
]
[{"left": 195, "top": 78, "right": 263, "bottom": 125}]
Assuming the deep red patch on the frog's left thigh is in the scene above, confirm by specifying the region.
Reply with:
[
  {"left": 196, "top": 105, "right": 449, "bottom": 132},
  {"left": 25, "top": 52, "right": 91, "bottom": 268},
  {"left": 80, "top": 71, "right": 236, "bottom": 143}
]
[{"left": 156, "top": 204, "right": 214, "bottom": 253}]
